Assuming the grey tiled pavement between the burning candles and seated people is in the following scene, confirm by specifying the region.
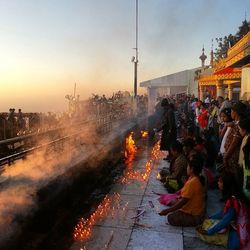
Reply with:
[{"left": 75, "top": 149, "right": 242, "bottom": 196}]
[{"left": 71, "top": 143, "right": 223, "bottom": 250}]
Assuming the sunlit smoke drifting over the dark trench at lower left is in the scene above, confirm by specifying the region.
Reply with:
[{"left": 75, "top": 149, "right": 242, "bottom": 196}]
[{"left": 0, "top": 115, "right": 111, "bottom": 244}]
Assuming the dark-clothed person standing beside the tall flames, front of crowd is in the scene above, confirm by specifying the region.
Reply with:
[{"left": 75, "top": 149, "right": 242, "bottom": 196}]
[{"left": 160, "top": 98, "right": 177, "bottom": 160}]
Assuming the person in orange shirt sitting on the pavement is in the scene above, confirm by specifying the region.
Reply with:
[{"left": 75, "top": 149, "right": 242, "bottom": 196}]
[{"left": 159, "top": 153, "right": 205, "bottom": 227}]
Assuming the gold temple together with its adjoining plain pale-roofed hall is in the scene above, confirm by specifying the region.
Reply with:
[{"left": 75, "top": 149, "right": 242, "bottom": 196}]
[{"left": 140, "top": 32, "right": 250, "bottom": 113}]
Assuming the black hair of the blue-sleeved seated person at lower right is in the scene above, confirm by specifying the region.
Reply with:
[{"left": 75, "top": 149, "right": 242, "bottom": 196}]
[{"left": 220, "top": 171, "right": 243, "bottom": 199}]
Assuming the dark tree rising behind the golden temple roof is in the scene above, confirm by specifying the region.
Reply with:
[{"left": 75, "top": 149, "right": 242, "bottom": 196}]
[{"left": 214, "top": 20, "right": 250, "bottom": 61}]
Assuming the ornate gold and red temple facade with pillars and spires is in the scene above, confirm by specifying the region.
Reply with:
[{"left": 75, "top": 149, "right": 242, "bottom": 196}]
[{"left": 197, "top": 32, "right": 250, "bottom": 101}]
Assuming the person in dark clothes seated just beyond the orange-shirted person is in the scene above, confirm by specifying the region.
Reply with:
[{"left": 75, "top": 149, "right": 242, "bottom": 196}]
[{"left": 165, "top": 141, "right": 187, "bottom": 193}]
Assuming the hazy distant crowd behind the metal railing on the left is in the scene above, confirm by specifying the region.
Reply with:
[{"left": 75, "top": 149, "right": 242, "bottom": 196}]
[{"left": 0, "top": 91, "right": 147, "bottom": 140}]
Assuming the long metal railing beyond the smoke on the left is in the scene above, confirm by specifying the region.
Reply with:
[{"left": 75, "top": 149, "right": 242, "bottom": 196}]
[{"left": 0, "top": 108, "right": 136, "bottom": 172}]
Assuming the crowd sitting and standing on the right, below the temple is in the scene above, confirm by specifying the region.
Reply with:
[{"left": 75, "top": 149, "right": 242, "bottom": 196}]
[{"left": 152, "top": 96, "right": 250, "bottom": 249}]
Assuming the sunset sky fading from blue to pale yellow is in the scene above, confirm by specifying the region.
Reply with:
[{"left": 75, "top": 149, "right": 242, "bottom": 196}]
[{"left": 0, "top": 0, "right": 250, "bottom": 112}]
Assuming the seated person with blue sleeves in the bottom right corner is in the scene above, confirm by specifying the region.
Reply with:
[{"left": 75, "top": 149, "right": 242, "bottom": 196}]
[{"left": 197, "top": 172, "right": 250, "bottom": 249}]
